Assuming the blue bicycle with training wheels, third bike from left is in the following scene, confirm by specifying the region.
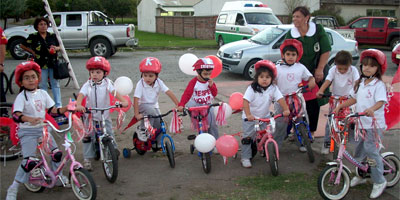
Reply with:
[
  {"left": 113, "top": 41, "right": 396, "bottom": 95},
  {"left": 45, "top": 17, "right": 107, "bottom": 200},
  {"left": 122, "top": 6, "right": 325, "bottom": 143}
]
[{"left": 122, "top": 110, "right": 180, "bottom": 168}]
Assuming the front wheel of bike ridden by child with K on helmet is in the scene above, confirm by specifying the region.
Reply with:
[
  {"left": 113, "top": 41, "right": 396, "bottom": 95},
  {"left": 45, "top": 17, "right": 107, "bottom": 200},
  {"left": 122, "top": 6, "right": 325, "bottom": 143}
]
[{"left": 102, "top": 140, "right": 118, "bottom": 183}]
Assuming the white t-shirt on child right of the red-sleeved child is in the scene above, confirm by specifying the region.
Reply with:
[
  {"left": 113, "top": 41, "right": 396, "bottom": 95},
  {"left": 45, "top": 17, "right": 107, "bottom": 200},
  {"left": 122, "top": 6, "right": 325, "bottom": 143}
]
[{"left": 242, "top": 84, "right": 283, "bottom": 119}]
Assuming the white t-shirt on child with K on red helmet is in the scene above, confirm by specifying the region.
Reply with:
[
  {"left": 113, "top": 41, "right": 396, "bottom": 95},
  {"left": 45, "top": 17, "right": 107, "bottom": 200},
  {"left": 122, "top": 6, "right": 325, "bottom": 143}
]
[{"left": 79, "top": 78, "right": 114, "bottom": 121}]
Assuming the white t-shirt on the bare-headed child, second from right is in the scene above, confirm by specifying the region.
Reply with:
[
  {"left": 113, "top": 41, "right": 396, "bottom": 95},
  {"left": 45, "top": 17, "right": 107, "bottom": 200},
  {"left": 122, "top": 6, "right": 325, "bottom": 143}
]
[{"left": 326, "top": 65, "right": 360, "bottom": 96}]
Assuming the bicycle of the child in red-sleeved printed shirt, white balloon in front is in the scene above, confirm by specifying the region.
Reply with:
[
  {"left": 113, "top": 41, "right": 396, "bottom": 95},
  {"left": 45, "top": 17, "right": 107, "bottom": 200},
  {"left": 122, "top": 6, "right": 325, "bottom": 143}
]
[{"left": 184, "top": 102, "right": 222, "bottom": 174}]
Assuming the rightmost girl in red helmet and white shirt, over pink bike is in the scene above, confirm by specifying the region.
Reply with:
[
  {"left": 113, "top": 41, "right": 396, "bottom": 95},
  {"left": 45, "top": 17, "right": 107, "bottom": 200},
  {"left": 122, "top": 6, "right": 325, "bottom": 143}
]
[{"left": 333, "top": 49, "right": 387, "bottom": 199}]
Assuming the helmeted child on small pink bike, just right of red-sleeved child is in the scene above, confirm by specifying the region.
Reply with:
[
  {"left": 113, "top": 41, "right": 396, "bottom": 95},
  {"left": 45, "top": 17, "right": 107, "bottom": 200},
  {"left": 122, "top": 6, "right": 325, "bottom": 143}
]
[{"left": 241, "top": 60, "right": 290, "bottom": 168}]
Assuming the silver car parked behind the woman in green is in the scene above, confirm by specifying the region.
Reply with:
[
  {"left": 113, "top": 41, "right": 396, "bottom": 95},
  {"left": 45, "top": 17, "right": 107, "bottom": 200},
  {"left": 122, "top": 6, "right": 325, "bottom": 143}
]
[{"left": 217, "top": 24, "right": 359, "bottom": 79}]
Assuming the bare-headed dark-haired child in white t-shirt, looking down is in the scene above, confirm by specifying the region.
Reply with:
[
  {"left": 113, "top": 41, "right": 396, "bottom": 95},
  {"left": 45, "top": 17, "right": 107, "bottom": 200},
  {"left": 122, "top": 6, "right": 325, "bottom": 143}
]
[{"left": 317, "top": 50, "right": 360, "bottom": 154}]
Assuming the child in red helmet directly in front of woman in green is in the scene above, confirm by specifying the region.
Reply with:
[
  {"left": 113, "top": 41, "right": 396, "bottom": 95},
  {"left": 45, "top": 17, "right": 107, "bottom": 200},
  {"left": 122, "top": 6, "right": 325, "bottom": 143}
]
[{"left": 275, "top": 39, "right": 315, "bottom": 152}]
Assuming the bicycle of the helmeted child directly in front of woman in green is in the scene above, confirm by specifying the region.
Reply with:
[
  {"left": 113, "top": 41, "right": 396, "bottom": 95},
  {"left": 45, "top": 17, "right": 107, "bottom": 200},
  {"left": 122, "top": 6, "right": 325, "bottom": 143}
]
[{"left": 285, "top": 84, "right": 315, "bottom": 163}]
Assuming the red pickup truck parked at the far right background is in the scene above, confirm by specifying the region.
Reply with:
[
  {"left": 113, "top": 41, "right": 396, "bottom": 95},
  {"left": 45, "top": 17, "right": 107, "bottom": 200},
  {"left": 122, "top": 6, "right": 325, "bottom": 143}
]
[{"left": 340, "top": 17, "right": 400, "bottom": 48}]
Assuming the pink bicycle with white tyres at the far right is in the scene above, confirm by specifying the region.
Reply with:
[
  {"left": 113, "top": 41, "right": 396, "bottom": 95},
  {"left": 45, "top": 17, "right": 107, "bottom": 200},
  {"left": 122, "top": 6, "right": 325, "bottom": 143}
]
[{"left": 318, "top": 113, "right": 400, "bottom": 199}]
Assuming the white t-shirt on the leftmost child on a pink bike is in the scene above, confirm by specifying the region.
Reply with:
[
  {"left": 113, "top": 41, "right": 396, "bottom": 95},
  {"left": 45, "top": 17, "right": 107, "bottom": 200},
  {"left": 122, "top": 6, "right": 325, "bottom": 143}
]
[{"left": 14, "top": 89, "right": 55, "bottom": 128}]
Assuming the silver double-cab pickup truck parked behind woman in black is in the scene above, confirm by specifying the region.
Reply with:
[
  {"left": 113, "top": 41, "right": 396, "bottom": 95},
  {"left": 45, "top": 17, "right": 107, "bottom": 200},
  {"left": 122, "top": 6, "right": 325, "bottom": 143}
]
[{"left": 4, "top": 11, "right": 138, "bottom": 59}]
